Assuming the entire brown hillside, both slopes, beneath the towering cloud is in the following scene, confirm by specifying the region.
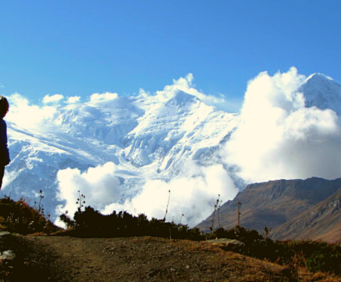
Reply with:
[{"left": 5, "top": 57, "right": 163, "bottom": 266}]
[{"left": 197, "top": 177, "right": 341, "bottom": 242}]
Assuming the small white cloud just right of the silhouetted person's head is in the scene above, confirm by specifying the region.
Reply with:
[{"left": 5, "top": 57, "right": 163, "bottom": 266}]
[{"left": 6, "top": 93, "right": 57, "bottom": 128}]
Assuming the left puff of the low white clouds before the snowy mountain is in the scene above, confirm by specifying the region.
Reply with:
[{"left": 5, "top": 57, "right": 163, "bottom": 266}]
[{"left": 57, "top": 162, "right": 120, "bottom": 214}]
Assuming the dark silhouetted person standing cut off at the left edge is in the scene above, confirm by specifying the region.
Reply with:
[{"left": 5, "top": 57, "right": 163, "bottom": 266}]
[{"left": 0, "top": 96, "right": 11, "bottom": 189}]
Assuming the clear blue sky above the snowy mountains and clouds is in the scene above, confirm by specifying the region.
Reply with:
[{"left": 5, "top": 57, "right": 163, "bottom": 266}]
[{"left": 0, "top": 0, "right": 341, "bottom": 108}]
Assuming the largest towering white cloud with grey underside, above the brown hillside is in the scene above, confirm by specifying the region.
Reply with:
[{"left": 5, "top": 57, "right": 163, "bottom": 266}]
[{"left": 222, "top": 68, "right": 341, "bottom": 182}]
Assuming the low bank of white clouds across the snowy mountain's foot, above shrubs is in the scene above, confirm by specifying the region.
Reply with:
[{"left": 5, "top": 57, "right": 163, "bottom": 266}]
[{"left": 57, "top": 163, "right": 238, "bottom": 226}]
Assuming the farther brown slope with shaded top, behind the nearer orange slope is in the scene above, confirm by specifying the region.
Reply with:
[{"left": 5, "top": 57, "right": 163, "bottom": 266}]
[{"left": 198, "top": 177, "right": 341, "bottom": 239}]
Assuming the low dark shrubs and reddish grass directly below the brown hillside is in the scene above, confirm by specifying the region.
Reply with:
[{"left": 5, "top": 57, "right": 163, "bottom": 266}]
[{"left": 210, "top": 226, "right": 341, "bottom": 275}]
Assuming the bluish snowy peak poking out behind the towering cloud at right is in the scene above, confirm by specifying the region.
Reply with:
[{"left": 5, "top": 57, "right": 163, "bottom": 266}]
[{"left": 298, "top": 73, "right": 341, "bottom": 115}]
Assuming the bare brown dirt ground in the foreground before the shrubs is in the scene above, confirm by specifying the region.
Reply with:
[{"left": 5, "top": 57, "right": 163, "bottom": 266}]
[{"left": 0, "top": 236, "right": 338, "bottom": 282}]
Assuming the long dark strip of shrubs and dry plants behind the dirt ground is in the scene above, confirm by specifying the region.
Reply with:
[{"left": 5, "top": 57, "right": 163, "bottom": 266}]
[{"left": 0, "top": 193, "right": 341, "bottom": 277}]
